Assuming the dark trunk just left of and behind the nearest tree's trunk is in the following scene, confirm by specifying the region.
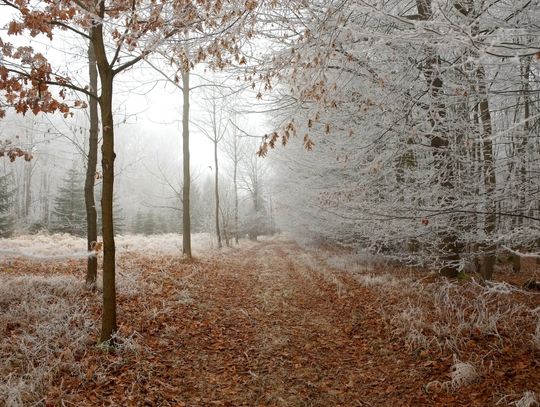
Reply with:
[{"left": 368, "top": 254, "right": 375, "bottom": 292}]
[{"left": 84, "top": 41, "right": 99, "bottom": 290}]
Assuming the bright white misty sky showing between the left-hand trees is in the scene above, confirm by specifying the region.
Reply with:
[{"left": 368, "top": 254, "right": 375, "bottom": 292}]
[{"left": 0, "top": 7, "right": 266, "bottom": 171}]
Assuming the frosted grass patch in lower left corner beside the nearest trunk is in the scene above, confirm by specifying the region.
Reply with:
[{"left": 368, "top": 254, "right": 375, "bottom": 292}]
[{"left": 0, "top": 274, "right": 97, "bottom": 407}]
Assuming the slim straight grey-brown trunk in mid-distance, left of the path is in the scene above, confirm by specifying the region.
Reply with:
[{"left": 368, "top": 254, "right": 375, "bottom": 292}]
[{"left": 182, "top": 70, "right": 191, "bottom": 259}]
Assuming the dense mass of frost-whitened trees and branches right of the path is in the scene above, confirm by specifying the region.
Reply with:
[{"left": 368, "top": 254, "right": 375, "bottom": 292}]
[{"left": 260, "top": 0, "right": 540, "bottom": 279}]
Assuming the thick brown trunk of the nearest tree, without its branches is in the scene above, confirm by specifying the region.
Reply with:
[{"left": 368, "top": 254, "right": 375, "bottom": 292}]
[{"left": 91, "top": 12, "right": 117, "bottom": 343}]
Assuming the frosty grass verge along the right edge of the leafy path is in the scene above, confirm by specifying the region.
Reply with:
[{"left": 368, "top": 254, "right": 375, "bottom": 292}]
[{"left": 288, "top": 242, "right": 540, "bottom": 407}]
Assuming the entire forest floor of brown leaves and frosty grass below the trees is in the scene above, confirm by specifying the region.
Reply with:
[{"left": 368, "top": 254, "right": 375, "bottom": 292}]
[{"left": 0, "top": 239, "right": 540, "bottom": 407}]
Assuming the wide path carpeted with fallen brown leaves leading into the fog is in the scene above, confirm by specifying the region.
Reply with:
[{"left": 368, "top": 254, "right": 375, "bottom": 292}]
[{"left": 48, "top": 241, "right": 462, "bottom": 406}]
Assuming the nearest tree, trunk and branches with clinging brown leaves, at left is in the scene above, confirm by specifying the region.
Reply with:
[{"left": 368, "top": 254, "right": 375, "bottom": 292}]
[{"left": 0, "top": 0, "right": 280, "bottom": 342}]
